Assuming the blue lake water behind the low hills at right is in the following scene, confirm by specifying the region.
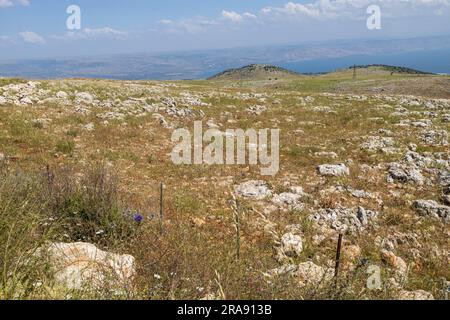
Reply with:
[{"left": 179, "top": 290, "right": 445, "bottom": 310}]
[{"left": 279, "top": 49, "right": 450, "bottom": 74}]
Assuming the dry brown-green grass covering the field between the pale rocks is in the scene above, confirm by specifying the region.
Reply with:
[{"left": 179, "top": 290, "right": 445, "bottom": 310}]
[{"left": 0, "top": 74, "right": 450, "bottom": 299}]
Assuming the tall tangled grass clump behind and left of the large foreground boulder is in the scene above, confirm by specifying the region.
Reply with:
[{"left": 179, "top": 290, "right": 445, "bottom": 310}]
[{"left": 0, "top": 163, "right": 137, "bottom": 299}]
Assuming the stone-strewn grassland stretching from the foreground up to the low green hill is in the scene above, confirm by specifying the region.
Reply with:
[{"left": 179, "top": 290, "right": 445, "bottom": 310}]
[{"left": 0, "top": 69, "right": 450, "bottom": 299}]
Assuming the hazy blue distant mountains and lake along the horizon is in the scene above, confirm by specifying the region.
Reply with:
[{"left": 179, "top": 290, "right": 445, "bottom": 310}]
[{"left": 0, "top": 36, "right": 450, "bottom": 80}]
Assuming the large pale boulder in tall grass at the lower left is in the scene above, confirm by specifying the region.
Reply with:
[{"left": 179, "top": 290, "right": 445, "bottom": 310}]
[{"left": 38, "top": 242, "right": 135, "bottom": 290}]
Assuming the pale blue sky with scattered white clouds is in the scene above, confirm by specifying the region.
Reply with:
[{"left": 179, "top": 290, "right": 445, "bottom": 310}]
[{"left": 0, "top": 0, "right": 450, "bottom": 59}]
